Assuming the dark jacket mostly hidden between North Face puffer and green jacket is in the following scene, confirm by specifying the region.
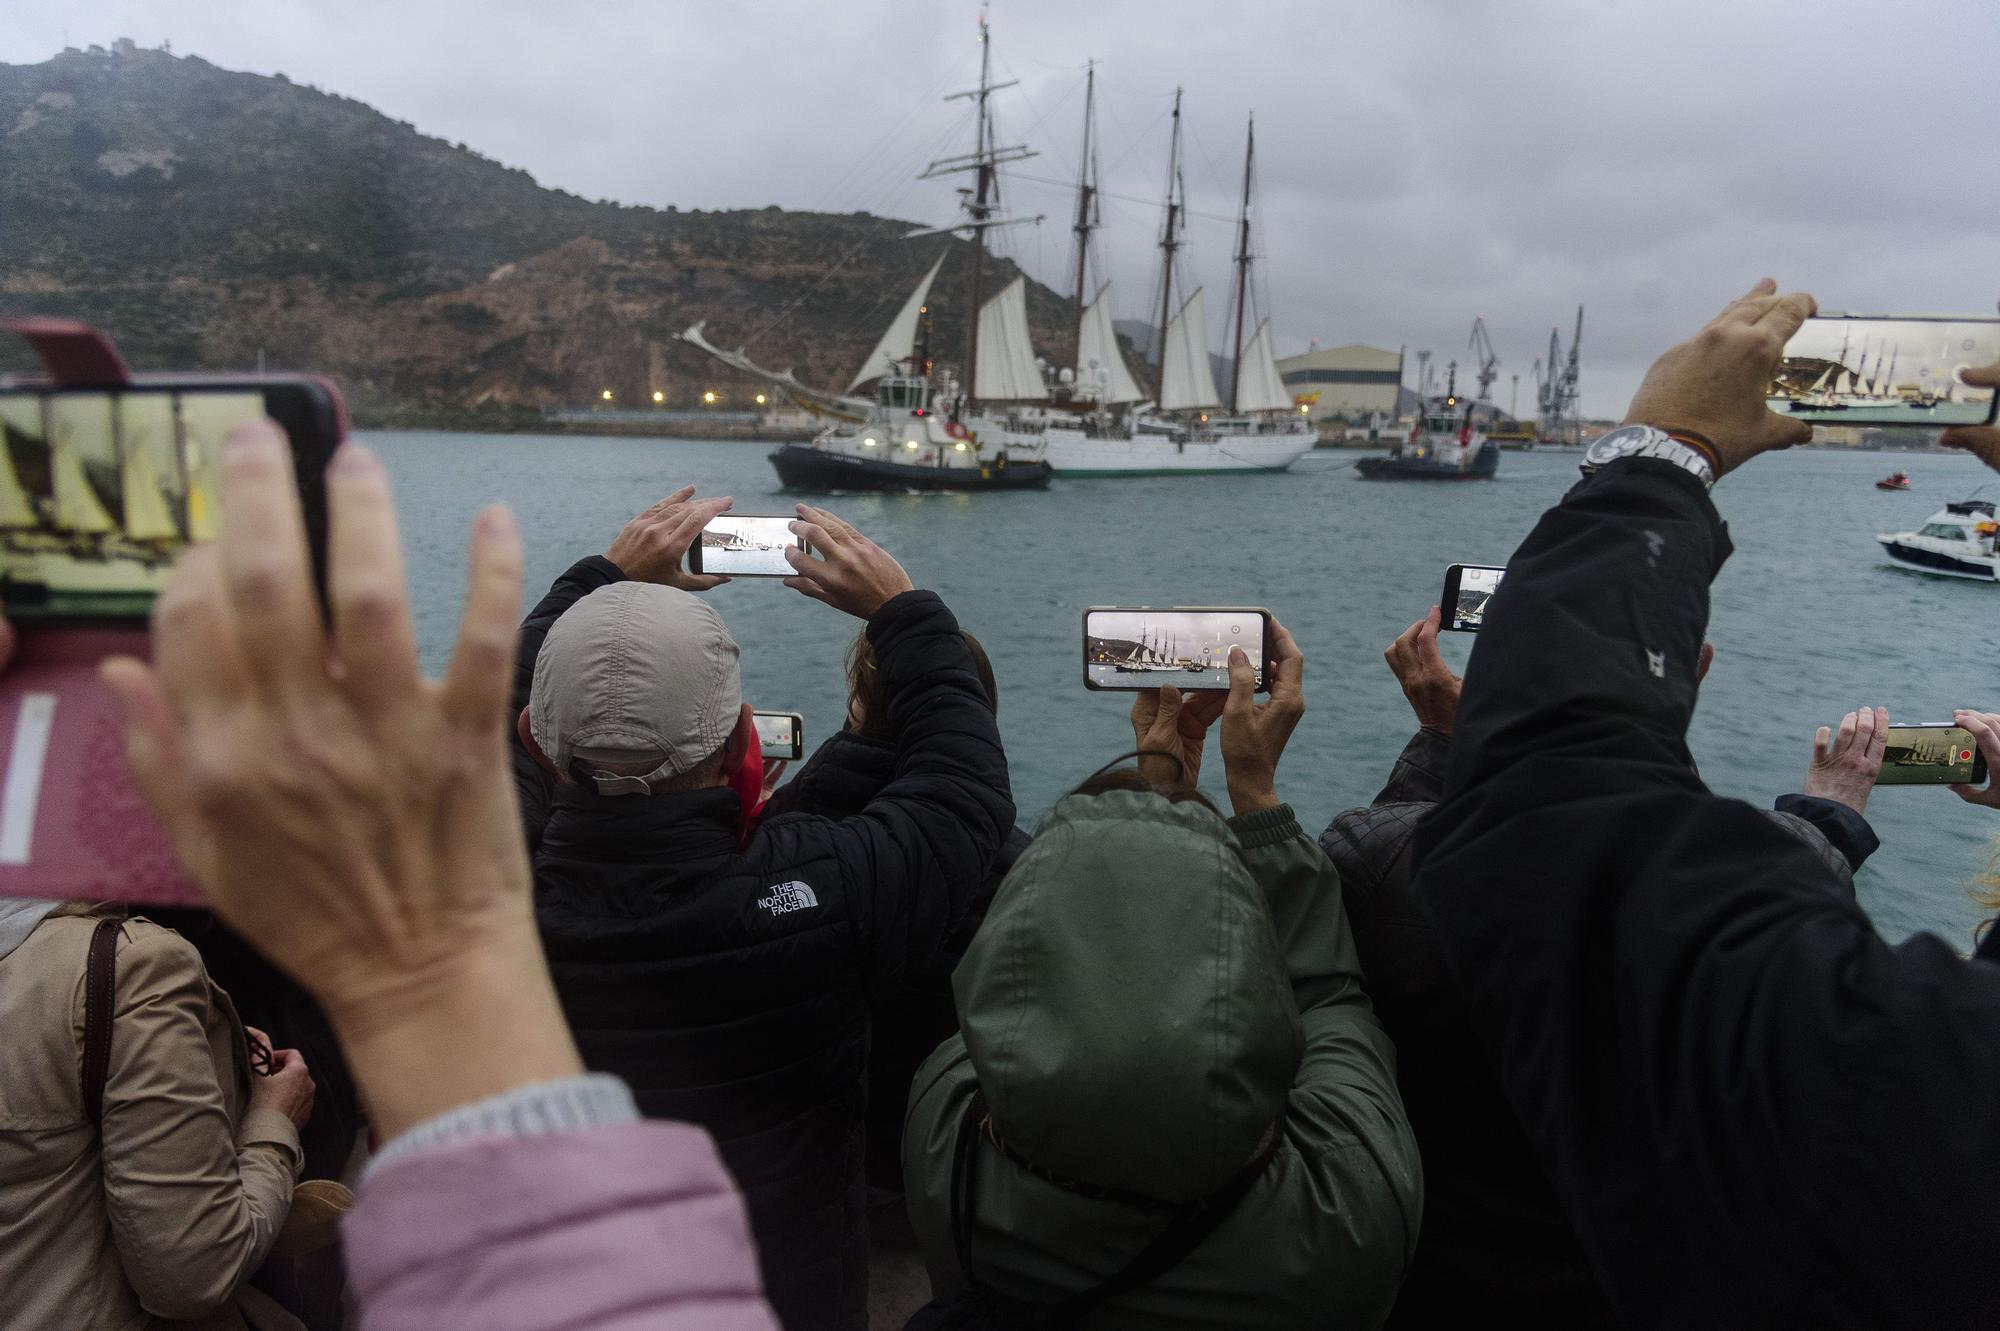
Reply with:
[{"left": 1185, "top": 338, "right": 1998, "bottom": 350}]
[{"left": 764, "top": 729, "right": 1028, "bottom": 1199}]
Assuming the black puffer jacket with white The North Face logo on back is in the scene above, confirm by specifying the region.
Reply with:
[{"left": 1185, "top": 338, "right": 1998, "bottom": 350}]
[{"left": 516, "top": 560, "right": 1014, "bottom": 1331}]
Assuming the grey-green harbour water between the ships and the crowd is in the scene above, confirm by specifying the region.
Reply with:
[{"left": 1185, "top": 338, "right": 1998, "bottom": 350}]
[{"left": 366, "top": 434, "right": 2000, "bottom": 947}]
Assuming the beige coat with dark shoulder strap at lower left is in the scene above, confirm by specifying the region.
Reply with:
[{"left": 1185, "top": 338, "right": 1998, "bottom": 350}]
[{"left": 0, "top": 905, "right": 300, "bottom": 1331}]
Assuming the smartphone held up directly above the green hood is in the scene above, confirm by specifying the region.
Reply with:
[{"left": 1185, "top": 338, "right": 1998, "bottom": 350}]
[{"left": 1084, "top": 606, "right": 1270, "bottom": 691}]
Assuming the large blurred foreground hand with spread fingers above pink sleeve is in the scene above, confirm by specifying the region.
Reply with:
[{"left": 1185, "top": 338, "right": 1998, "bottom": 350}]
[{"left": 104, "top": 422, "right": 580, "bottom": 1135}]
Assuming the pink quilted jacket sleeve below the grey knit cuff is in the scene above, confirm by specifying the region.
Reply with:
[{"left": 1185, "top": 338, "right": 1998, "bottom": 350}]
[{"left": 344, "top": 1123, "right": 778, "bottom": 1331}]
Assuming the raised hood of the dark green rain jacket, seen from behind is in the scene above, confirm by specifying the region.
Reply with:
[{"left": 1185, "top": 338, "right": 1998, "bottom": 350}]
[{"left": 952, "top": 791, "right": 1304, "bottom": 1203}]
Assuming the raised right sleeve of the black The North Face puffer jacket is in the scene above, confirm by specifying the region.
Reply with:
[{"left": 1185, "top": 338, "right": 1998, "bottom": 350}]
[{"left": 834, "top": 592, "right": 1014, "bottom": 997}]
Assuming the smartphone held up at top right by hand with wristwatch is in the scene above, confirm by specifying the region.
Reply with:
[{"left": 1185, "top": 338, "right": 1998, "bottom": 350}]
[{"left": 1764, "top": 314, "right": 2000, "bottom": 430}]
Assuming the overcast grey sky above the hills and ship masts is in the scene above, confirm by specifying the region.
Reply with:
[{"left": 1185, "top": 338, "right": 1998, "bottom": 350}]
[{"left": 0, "top": 0, "right": 2000, "bottom": 416}]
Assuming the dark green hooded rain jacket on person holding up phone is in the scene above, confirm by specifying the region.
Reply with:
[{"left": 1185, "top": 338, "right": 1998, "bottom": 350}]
[{"left": 902, "top": 791, "right": 1422, "bottom": 1329}]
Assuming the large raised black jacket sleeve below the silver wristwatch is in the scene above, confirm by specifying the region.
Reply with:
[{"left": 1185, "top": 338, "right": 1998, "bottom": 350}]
[{"left": 1416, "top": 460, "right": 2000, "bottom": 1327}]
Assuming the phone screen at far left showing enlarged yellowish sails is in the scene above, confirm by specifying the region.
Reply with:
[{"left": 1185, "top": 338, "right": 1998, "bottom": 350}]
[{"left": 0, "top": 390, "right": 264, "bottom": 618}]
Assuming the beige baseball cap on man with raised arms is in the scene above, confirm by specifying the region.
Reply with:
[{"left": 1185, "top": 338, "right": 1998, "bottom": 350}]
[{"left": 528, "top": 582, "right": 742, "bottom": 795}]
